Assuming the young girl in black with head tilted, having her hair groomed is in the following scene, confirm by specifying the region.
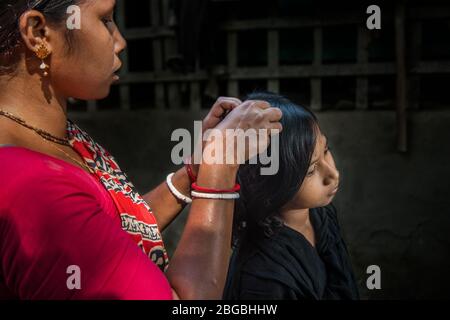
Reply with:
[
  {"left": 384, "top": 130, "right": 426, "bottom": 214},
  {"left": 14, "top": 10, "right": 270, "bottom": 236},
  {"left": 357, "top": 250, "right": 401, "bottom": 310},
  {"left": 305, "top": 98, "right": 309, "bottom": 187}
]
[{"left": 224, "top": 93, "right": 359, "bottom": 300}]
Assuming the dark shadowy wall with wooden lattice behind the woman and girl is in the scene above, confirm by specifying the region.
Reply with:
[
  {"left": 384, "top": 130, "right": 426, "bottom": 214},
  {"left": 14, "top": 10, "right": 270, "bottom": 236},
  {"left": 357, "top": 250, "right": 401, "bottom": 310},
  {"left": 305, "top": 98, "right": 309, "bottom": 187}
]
[{"left": 70, "top": 0, "right": 450, "bottom": 299}]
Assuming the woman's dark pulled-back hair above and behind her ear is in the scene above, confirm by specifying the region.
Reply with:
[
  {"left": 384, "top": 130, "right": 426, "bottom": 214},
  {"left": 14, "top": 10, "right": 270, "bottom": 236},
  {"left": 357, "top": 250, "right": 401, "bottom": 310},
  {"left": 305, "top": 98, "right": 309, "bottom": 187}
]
[{"left": 0, "top": 0, "right": 81, "bottom": 74}]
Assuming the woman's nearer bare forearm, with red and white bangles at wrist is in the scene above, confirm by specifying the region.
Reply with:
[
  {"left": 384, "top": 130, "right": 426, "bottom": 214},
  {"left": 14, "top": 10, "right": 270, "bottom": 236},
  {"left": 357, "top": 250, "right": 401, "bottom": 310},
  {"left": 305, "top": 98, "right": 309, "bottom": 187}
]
[{"left": 166, "top": 165, "right": 237, "bottom": 299}]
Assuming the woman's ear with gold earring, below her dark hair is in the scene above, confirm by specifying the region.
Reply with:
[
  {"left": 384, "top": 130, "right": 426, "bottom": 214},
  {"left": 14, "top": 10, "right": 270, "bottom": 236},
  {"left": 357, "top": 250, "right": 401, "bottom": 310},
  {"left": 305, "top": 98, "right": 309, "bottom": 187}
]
[{"left": 19, "top": 10, "right": 52, "bottom": 53}]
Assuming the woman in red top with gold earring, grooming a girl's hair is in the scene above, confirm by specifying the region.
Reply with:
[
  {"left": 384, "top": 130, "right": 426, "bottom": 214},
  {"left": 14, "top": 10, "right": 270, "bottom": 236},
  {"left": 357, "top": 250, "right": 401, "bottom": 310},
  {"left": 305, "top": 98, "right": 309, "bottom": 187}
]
[{"left": 0, "top": 0, "right": 281, "bottom": 299}]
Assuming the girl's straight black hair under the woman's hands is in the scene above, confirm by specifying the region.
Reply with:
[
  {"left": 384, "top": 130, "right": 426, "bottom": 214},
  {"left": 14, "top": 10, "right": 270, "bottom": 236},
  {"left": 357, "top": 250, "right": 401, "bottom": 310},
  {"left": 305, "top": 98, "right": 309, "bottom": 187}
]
[{"left": 233, "top": 92, "right": 318, "bottom": 245}]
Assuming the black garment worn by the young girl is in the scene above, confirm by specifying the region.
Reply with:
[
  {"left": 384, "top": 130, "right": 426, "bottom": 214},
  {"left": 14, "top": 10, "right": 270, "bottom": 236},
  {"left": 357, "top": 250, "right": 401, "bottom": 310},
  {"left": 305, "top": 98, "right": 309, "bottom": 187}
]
[{"left": 223, "top": 205, "right": 359, "bottom": 300}]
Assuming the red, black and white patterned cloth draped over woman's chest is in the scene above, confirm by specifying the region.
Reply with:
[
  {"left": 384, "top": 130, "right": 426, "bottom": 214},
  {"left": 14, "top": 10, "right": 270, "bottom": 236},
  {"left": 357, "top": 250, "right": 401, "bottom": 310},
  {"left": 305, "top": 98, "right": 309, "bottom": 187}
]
[{"left": 67, "top": 120, "right": 169, "bottom": 271}]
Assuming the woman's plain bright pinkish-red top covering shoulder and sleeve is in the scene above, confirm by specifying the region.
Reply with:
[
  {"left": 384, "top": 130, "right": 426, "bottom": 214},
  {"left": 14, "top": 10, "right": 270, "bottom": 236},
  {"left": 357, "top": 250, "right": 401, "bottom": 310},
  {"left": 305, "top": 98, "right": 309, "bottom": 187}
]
[{"left": 0, "top": 148, "right": 171, "bottom": 300}]
